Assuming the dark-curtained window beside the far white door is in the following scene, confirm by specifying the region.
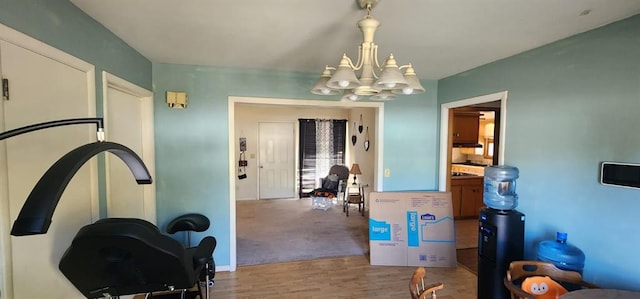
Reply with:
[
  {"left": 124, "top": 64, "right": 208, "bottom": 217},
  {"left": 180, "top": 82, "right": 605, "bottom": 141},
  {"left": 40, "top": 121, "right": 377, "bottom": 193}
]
[{"left": 298, "top": 119, "right": 347, "bottom": 198}]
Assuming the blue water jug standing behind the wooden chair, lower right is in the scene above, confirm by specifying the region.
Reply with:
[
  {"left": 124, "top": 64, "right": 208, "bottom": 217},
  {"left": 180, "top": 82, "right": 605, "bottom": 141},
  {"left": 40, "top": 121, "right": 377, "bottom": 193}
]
[{"left": 537, "top": 232, "right": 585, "bottom": 274}]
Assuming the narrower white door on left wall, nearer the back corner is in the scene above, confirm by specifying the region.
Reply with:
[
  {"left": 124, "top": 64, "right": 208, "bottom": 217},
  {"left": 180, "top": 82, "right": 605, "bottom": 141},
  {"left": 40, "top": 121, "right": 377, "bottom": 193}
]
[{"left": 103, "top": 73, "right": 156, "bottom": 223}]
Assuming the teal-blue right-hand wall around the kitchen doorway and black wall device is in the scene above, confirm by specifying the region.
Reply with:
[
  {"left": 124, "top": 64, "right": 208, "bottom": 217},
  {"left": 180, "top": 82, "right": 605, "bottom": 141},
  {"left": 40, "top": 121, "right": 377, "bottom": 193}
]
[{"left": 438, "top": 16, "right": 640, "bottom": 290}]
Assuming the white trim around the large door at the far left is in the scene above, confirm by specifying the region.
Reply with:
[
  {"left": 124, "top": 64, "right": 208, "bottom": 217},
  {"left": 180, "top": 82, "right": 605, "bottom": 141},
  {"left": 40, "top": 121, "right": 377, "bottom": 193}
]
[{"left": 0, "top": 24, "right": 99, "bottom": 298}]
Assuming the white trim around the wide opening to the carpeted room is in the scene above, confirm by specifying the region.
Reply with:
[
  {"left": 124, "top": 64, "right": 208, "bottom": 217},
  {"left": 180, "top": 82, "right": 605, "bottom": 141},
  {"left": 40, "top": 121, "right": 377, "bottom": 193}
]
[{"left": 228, "top": 96, "right": 384, "bottom": 272}]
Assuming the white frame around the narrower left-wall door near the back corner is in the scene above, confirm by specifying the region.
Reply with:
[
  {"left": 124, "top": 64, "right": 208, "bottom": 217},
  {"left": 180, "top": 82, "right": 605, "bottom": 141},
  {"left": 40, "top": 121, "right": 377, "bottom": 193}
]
[{"left": 102, "top": 71, "right": 157, "bottom": 224}]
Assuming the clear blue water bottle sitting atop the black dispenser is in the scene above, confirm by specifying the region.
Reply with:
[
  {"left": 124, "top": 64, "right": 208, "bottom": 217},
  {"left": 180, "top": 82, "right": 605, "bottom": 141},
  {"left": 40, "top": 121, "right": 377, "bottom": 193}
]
[{"left": 484, "top": 165, "right": 519, "bottom": 210}]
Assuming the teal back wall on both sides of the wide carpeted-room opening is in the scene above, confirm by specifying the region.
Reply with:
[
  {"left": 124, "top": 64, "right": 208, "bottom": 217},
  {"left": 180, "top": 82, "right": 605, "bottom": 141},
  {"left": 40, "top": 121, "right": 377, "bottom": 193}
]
[{"left": 153, "top": 63, "right": 437, "bottom": 266}]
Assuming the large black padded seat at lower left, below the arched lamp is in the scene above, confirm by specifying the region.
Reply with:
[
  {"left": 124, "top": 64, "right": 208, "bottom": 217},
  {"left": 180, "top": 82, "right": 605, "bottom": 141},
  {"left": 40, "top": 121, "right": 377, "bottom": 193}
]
[{"left": 59, "top": 218, "right": 216, "bottom": 298}]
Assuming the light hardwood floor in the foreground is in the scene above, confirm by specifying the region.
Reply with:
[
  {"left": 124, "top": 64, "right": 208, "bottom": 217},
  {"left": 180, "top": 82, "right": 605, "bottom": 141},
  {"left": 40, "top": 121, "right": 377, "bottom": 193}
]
[{"left": 211, "top": 256, "right": 477, "bottom": 299}]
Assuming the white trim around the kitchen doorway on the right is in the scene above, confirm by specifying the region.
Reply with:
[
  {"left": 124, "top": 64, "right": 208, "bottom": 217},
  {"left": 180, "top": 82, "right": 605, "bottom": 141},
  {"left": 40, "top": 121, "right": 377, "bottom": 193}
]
[{"left": 438, "top": 91, "right": 508, "bottom": 191}]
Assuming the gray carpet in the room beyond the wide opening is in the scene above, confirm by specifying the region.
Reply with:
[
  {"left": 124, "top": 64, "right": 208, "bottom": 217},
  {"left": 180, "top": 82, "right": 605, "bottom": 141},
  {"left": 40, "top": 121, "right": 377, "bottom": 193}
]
[{"left": 236, "top": 199, "right": 369, "bottom": 266}]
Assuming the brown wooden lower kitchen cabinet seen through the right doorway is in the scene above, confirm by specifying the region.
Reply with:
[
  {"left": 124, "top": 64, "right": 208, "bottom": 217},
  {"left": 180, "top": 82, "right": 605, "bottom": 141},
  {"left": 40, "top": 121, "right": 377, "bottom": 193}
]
[{"left": 451, "top": 176, "right": 484, "bottom": 218}]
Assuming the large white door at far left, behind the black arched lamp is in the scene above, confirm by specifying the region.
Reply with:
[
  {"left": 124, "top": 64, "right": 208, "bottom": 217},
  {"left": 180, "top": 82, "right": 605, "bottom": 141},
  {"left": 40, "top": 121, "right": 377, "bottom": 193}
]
[{"left": 0, "top": 36, "right": 97, "bottom": 299}]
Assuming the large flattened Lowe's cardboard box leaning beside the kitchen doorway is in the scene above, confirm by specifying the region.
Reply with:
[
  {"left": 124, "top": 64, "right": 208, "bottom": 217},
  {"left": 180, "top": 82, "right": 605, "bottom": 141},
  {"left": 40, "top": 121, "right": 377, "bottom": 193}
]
[{"left": 369, "top": 192, "right": 457, "bottom": 267}]
